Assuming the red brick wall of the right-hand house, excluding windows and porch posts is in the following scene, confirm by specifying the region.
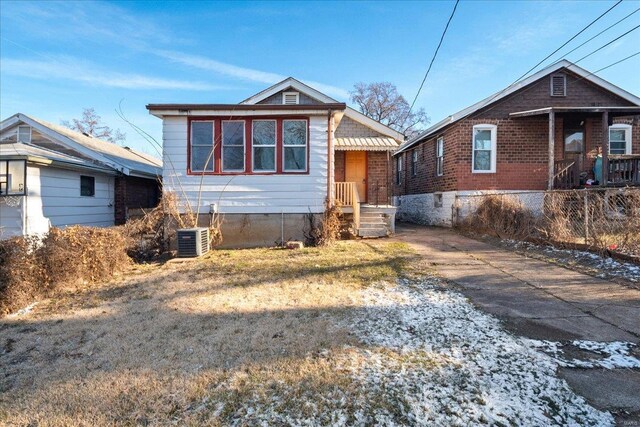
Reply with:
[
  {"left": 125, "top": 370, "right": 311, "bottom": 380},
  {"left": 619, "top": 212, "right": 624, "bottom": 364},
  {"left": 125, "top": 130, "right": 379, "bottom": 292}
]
[{"left": 392, "top": 68, "right": 640, "bottom": 195}]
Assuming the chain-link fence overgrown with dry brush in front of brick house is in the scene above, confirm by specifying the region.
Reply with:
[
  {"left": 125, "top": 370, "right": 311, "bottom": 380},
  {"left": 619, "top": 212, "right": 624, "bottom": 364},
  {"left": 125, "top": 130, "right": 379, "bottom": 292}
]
[{"left": 452, "top": 187, "right": 640, "bottom": 256}]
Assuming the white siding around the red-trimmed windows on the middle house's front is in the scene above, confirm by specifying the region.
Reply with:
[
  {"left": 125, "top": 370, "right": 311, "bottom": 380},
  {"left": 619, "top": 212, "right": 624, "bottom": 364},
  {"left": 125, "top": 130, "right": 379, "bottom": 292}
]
[{"left": 162, "top": 116, "right": 327, "bottom": 213}]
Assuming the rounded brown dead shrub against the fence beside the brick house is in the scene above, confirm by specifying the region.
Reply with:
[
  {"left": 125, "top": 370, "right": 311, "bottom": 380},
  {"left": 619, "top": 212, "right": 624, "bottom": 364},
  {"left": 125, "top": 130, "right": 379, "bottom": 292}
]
[{"left": 461, "top": 195, "right": 538, "bottom": 240}]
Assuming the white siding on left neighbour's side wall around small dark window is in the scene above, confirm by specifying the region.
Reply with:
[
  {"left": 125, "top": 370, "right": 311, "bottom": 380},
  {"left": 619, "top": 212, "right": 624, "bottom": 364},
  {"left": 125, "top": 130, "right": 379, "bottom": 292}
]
[{"left": 25, "top": 165, "right": 114, "bottom": 234}]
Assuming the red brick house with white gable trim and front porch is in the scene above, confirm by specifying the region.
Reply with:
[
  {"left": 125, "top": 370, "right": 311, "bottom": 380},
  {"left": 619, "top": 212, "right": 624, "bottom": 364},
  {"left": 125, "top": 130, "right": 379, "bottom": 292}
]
[{"left": 393, "top": 60, "right": 640, "bottom": 225}]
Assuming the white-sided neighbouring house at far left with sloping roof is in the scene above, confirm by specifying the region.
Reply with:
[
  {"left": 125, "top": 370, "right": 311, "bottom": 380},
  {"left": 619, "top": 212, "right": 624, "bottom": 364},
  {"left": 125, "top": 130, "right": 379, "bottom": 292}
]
[{"left": 0, "top": 114, "right": 161, "bottom": 238}]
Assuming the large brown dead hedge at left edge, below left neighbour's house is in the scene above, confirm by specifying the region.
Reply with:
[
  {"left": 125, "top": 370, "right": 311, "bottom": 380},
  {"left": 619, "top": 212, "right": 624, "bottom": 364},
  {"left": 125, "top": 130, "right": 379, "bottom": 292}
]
[{"left": 0, "top": 226, "right": 131, "bottom": 314}]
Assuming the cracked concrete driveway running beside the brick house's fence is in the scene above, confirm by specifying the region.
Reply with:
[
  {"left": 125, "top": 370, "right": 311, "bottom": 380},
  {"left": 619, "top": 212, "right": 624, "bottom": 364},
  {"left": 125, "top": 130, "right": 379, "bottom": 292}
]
[{"left": 396, "top": 225, "right": 640, "bottom": 425}]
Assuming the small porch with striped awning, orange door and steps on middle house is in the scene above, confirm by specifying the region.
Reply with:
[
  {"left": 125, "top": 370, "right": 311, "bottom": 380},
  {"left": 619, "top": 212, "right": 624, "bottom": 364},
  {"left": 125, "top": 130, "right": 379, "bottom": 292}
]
[{"left": 332, "top": 136, "right": 398, "bottom": 237}]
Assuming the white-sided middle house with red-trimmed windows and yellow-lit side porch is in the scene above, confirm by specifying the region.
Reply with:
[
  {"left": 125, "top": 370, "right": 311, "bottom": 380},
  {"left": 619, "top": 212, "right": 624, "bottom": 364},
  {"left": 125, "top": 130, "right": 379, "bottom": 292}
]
[{"left": 147, "top": 78, "right": 403, "bottom": 247}]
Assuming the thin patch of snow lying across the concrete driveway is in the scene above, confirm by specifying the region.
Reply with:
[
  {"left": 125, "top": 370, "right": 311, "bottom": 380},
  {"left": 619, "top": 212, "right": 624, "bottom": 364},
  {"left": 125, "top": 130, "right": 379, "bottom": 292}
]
[{"left": 527, "top": 340, "right": 640, "bottom": 369}]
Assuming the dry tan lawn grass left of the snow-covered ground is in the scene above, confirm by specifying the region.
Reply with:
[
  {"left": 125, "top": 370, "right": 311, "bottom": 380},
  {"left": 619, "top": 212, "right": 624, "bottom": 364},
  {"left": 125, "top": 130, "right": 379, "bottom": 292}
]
[{"left": 0, "top": 241, "right": 414, "bottom": 425}]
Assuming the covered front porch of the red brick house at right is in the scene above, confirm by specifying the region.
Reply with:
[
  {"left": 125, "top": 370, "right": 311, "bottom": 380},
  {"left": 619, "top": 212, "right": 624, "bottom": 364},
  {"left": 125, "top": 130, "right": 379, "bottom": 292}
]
[{"left": 510, "top": 107, "right": 640, "bottom": 190}]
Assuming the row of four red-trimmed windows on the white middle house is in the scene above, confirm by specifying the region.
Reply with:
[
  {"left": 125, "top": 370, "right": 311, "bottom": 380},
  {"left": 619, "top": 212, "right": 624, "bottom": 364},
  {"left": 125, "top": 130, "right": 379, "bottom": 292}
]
[{"left": 188, "top": 117, "right": 309, "bottom": 175}]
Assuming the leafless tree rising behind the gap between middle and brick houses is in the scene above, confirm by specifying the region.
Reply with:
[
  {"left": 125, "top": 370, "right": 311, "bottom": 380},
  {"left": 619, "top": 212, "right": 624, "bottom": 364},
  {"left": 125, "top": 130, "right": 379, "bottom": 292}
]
[{"left": 350, "top": 82, "right": 429, "bottom": 137}]
